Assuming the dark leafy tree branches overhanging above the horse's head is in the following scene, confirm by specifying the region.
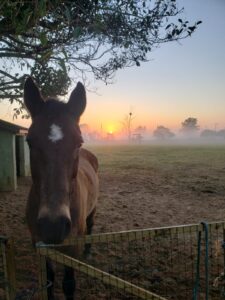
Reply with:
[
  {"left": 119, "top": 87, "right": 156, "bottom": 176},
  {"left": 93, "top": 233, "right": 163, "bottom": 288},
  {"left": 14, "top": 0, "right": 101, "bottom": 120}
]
[{"left": 0, "top": 0, "right": 201, "bottom": 112}]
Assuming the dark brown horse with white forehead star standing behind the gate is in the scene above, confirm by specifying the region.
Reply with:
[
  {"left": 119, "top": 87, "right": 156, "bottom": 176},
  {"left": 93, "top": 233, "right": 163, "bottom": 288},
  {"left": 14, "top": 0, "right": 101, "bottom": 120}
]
[{"left": 24, "top": 78, "right": 99, "bottom": 300}]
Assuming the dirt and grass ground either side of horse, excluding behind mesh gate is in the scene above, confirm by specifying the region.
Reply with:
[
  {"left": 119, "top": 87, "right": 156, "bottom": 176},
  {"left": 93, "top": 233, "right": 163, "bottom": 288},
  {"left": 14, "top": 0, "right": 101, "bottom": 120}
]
[{"left": 0, "top": 146, "right": 225, "bottom": 298}]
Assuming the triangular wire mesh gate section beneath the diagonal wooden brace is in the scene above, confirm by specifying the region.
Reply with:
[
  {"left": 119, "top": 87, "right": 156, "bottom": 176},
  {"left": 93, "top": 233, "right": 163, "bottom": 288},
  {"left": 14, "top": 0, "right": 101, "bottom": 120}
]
[{"left": 36, "top": 245, "right": 166, "bottom": 300}]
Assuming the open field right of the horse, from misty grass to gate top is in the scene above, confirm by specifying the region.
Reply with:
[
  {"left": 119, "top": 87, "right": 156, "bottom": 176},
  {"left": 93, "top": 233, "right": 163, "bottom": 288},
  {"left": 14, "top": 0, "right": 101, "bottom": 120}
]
[{"left": 83, "top": 145, "right": 225, "bottom": 230}]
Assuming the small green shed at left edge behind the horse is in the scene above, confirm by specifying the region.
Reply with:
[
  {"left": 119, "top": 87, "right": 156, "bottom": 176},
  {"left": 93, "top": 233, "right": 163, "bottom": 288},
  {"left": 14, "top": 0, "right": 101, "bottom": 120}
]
[{"left": 0, "top": 119, "right": 30, "bottom": 191}]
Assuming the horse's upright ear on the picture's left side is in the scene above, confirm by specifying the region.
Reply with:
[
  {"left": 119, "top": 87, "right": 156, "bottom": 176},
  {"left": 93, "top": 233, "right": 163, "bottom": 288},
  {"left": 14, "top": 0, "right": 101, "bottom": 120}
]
[{"left": 24, "top": 77, "right": 44, "bottom": 118}]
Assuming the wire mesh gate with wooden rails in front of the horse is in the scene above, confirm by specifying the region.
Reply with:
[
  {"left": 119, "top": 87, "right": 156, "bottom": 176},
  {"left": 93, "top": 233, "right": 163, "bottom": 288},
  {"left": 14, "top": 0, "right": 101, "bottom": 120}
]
[{"left": 37, "top": 222, "right": 225, "bottom": 300}]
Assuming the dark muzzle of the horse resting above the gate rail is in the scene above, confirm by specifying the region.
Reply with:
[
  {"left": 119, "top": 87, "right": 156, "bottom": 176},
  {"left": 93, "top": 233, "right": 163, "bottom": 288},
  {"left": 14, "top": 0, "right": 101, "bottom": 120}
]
[{"left": 37, "top": 216, "right": 71, "bottom": 244}]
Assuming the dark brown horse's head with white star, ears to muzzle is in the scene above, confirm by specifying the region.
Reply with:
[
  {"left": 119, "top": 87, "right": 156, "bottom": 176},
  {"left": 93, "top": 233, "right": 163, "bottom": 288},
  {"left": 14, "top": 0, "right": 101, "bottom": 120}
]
[{"left": 24, "top": 77, "right": 86, "bottom": 243}]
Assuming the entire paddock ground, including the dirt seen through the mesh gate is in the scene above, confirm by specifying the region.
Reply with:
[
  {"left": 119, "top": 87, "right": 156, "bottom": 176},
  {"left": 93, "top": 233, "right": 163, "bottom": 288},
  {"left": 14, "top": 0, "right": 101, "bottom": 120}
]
[{"left": 0, "top": 145, "right": 225, "bottom": 299}]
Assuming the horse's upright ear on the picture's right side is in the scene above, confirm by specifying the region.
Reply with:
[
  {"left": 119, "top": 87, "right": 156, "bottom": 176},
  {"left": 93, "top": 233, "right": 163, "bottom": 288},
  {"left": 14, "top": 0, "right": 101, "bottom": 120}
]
[{"left": 67, "top": 82, "right": 86, "bottom": 120}]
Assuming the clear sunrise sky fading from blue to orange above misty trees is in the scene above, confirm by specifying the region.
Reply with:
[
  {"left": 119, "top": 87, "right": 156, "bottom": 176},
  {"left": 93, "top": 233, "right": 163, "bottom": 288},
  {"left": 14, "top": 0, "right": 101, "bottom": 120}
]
[{"left": 0, "top": 0, "right": 225, "bottom": 134}]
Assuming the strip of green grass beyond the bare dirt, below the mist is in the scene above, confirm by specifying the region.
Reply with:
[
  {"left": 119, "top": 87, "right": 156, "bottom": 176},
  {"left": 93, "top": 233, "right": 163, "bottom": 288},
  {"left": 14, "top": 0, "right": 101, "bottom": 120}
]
[{"left": 89, "top": 145, "right": 225, "bottom": 171}]
